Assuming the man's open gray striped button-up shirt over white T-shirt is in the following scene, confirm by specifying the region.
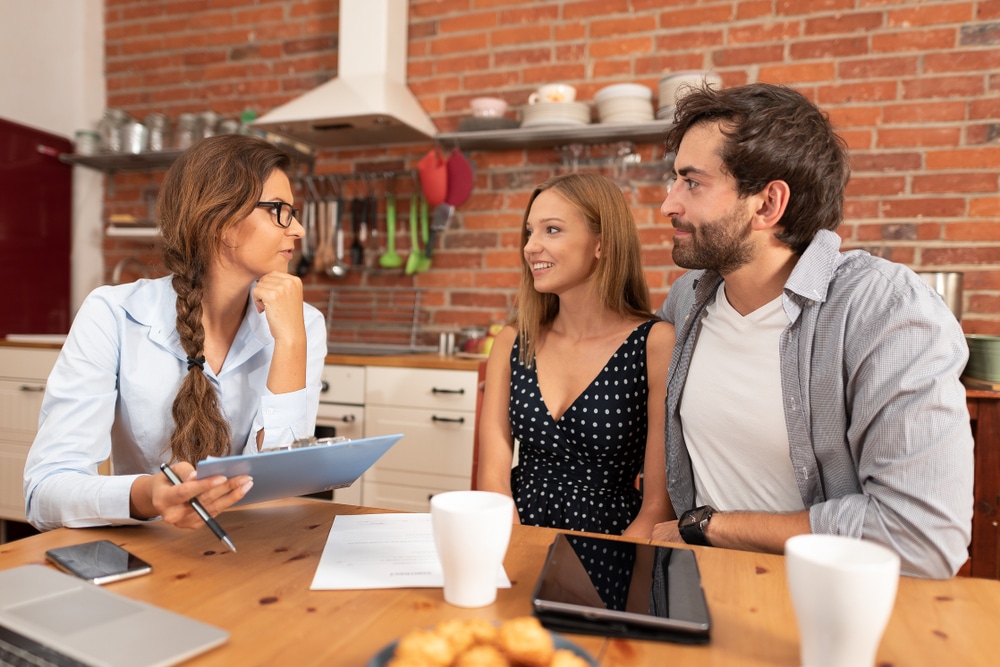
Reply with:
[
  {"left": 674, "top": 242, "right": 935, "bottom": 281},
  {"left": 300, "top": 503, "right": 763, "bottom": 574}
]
[{"left": 658, "top": 230, "right": 973, "bottom": 578}]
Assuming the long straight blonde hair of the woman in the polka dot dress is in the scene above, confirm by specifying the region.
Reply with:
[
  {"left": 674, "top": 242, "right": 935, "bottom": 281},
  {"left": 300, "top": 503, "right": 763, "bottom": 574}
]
[{"left": 508, "top": 173, "right": 651, "bottom": 366}]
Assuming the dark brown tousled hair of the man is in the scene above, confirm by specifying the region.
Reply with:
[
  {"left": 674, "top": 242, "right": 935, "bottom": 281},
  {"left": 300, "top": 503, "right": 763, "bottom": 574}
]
[{"left": 666, "top": 83, "right": 851, "bottom": 254}]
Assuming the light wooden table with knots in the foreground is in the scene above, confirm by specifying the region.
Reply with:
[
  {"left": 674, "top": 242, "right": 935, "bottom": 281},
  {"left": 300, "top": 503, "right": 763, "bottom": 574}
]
[{"left": 0, "top": 499, "right": 1000, "bottom": 667}]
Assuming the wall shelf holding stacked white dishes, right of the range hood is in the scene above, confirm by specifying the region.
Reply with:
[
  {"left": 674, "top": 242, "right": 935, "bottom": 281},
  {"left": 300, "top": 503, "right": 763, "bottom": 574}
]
[{"left": 435, "top": 120, "right": 674, "bottom": 150}]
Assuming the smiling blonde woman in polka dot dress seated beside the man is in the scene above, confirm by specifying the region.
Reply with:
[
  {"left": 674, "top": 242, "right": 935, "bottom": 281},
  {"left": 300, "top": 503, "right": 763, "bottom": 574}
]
[{"left": 478, "top": 173, "right": 674, "bottom": 538}]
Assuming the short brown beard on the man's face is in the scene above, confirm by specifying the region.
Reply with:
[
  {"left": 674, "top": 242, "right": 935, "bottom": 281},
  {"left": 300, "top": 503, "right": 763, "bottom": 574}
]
[{"left": 671, "top": 202, "right": 754, "bottom": 275}]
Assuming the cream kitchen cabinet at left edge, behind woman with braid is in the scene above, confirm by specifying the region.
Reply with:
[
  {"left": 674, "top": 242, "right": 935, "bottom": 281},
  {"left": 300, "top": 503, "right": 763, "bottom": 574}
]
[{"left": 0, "top": 347, "right": 59, "bottom": 521}]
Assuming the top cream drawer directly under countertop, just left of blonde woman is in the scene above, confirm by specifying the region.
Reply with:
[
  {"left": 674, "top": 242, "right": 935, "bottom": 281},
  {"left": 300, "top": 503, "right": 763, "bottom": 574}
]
[{"left": 365, "top": 366, "right": 477, "bottom": 412}]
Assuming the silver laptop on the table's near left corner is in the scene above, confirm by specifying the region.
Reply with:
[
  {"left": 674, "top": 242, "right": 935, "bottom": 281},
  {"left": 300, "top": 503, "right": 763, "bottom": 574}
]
[{"left": 0, "top": 565, "right": 229, "bottom": 667}]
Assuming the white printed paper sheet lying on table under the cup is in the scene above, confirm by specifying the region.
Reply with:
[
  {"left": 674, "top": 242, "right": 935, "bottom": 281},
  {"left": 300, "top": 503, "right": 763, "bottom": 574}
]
[{"left": 310, "top": 513, "right": 510, "bottom": 591}]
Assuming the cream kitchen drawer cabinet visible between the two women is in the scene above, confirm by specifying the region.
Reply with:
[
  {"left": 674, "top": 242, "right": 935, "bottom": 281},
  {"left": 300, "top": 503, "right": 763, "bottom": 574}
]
[{"left": 362, "top": 366, "right": 477, "bottom": 512}]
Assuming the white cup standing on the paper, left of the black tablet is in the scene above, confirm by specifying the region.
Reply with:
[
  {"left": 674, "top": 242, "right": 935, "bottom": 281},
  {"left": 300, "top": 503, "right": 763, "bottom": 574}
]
[{"left": 431, "top": 491, "right": 514, "bottom": 607}]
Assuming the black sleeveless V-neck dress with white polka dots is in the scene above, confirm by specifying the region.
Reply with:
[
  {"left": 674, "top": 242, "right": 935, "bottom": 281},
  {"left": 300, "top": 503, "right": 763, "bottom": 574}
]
[{"left": 509, "top": 320, "right": 654, "bottom": 535}]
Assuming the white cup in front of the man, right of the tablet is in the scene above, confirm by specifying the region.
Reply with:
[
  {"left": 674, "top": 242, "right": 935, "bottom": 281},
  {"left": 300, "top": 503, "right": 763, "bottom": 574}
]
[{"left": 785, "top": 535, "right": 899, "bottom": 667}]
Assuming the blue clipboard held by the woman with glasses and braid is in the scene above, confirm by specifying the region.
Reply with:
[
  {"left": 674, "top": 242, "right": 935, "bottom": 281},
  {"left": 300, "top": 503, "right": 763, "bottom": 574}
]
[{"left": 197, "top": 433, "right": 403, "bottom": 505}]
